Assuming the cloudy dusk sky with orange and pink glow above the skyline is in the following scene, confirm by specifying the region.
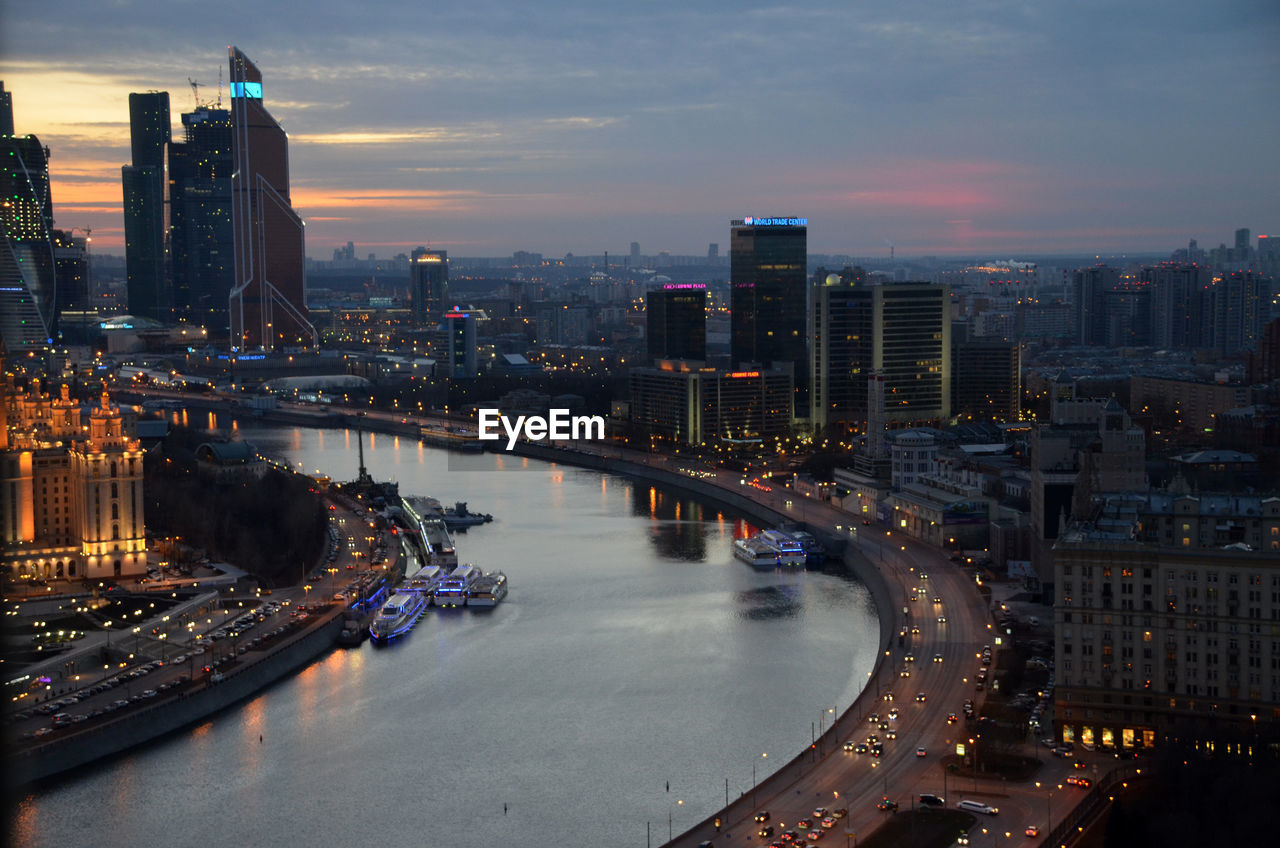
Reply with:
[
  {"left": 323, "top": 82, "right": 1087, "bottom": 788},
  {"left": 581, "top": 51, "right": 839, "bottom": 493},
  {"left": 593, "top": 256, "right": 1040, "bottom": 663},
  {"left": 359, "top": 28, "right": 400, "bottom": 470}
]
[{"left": 0, "top": 0, "right": 1280, "bottom": 259}]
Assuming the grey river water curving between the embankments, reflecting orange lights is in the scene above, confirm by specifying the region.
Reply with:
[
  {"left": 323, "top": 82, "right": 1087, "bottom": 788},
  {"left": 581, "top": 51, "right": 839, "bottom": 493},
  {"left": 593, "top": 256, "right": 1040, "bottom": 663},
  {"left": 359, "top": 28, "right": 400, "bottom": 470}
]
[{"left": 10, "top": 428, "right": 878, "bottom": 848}]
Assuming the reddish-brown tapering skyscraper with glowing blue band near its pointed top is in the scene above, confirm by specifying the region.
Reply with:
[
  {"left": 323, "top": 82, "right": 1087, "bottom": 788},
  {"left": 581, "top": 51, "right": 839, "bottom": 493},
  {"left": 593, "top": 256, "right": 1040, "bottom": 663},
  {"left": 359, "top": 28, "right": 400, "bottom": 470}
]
[{"left": 228, "top": 47, "right": 317, "bottom": 351}]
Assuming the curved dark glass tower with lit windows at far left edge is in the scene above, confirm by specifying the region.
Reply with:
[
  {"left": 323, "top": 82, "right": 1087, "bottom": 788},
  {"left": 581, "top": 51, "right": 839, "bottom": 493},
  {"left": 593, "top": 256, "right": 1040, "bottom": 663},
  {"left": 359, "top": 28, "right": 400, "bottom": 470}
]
[{"left": 0, "top": 83, "right": 58, "bottom": 354}]
